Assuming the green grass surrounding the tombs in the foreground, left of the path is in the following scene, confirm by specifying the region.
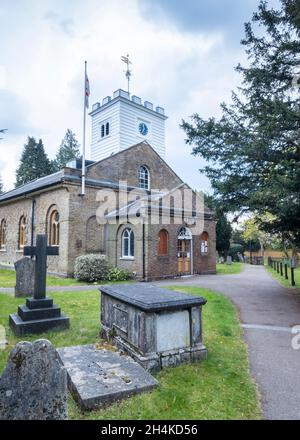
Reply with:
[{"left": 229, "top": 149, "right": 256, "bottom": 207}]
[{"left": 0, "top": 287, "right": 261, "bottom": 420}]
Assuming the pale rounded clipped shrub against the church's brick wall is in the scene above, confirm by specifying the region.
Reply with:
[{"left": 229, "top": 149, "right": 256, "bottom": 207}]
[{"left": 74, "top": 254, "right": 109, "bottom": 282}]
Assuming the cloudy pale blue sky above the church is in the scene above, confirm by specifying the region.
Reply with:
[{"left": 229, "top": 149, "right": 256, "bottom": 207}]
[{"left": 0, "top": 0, "right": 278, "bottom": 190}]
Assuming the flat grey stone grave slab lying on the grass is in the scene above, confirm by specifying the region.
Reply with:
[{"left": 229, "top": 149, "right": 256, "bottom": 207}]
[{"left": 57, "top": 345, "right": 158, "bottom": 410}]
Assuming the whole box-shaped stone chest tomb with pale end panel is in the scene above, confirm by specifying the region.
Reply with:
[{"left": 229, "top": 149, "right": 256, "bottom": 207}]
[{"left": 100, "top": 284, "right": 207, "bottom": 371}]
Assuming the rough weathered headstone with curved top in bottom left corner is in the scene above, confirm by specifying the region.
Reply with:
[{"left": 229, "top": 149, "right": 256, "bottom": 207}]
[{"left": 0, "top": 339, "right": 67, "bottom": 420}]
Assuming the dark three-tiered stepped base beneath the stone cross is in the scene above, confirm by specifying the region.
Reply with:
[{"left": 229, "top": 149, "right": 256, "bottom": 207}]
[{"left": 9, "top": 298, "right": 70, "bottom": 336}]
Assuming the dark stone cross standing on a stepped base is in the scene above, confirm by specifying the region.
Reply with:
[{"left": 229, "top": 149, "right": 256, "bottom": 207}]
[{"left": 9, "top": 234, "right": 69, "bottom": 336}]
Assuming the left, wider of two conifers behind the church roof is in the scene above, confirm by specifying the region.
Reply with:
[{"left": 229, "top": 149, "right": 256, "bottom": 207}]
[{"left": 16, "top": 136, "right": 53, "bottom": 187}]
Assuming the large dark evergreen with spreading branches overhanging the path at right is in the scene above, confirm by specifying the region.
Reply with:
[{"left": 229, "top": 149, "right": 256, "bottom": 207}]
[{"left": 182, "top": 0, "right": 300, "bottom": 251}]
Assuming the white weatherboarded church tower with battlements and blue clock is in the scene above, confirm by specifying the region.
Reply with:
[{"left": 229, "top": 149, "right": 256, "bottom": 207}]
[{"left": 90, "top": 89, "right": 167, "bottom": 161}]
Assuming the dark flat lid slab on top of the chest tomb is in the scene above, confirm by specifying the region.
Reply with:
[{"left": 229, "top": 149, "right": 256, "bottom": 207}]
[{"left": 99, "top": 283, "right": 206, "bottom": 312}]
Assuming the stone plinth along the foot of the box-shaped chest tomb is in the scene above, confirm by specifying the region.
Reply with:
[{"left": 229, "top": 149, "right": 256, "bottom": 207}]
[{"left": 101, "top": 327, "right": 207, "bottom": 373}]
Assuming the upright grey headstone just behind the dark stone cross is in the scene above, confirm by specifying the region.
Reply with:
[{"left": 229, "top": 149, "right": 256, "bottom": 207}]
[{"left": 15, "top": 257, "right": 34, "bottom": 296}]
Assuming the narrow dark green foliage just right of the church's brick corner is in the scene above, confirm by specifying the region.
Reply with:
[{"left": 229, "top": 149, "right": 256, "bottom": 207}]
[{"left": 204, "top": 194, "right": 232, "bottom": 256}]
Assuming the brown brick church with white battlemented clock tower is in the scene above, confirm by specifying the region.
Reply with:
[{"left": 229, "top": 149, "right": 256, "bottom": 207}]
[{"left": 0, "top": 90, "right": 216, "bottom": 281}]
